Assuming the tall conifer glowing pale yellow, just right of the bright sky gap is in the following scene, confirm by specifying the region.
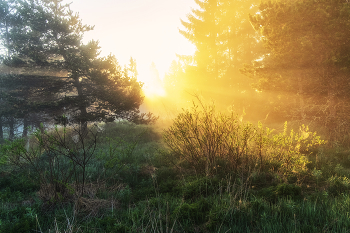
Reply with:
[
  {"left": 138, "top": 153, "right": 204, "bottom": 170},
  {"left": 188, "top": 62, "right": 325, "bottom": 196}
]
[{"left": 165, "top": 0, "right": 262, "bottom": 116}]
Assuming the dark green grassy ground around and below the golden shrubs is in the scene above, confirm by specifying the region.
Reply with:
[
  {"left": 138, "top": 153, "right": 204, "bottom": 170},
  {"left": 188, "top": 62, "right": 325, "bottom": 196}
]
[{"left": 0, "top": 119, "right": 350, "bottom": 233}]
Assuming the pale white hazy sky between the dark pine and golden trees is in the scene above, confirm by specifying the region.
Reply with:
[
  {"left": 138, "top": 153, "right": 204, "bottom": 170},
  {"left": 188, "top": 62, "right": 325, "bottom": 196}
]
[{"left": 67, "top": 0, "right": 196, "bottom": 82}]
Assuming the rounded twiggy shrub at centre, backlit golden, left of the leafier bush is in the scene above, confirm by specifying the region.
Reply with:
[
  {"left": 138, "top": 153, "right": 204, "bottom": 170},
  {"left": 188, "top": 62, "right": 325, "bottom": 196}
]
[{"left": 164, "top": 101, "right": 253, "bottom": 176}]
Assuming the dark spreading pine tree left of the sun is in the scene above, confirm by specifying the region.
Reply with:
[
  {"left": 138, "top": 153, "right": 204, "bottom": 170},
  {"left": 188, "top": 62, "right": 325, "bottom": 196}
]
[{"left": 0, "top": 0, "right": 143, "bottom": 131}]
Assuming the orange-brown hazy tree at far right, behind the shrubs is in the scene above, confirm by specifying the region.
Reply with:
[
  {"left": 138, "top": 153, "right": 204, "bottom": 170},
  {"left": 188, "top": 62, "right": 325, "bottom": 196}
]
[{"left": 244, "top": 0, "right": 350, "bottom": 138}]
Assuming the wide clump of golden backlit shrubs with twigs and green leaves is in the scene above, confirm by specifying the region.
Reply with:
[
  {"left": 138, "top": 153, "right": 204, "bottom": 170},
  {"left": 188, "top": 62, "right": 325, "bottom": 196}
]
[{"left": 164, "top": 101, "right": 324, "bottom": 177}]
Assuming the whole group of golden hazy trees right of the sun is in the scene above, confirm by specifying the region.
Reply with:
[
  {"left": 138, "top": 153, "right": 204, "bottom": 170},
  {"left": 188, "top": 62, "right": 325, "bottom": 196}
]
[{"left": 166, "top": 0, "right": 350, "bottom": 142}]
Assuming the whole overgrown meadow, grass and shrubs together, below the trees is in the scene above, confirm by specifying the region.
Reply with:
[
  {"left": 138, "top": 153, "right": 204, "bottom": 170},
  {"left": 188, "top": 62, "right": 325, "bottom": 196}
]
[{"left": 0, "top": 103, "right": 350, "bottom": 233}]
